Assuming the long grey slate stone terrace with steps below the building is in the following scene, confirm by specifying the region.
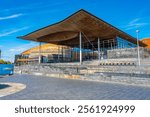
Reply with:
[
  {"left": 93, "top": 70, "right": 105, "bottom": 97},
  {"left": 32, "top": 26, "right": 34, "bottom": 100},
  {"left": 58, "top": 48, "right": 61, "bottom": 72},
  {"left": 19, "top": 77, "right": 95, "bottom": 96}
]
[{"left": 15, "top": 59, "right": 150, "bottom": 86}]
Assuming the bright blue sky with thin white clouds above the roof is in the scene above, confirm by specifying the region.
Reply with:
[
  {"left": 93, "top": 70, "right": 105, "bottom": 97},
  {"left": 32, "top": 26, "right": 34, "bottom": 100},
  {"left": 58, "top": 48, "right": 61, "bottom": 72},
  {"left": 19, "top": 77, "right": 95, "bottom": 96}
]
[{"left": 0, "top": 0, "right": 150, "bottom": 61}]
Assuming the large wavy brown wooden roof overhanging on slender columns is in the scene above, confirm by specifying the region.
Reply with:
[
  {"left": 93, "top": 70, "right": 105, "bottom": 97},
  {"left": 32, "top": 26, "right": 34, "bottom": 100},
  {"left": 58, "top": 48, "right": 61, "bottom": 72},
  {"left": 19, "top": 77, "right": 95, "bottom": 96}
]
[{"left": 19, "top": 9, "right": 145, "bottom": 46}]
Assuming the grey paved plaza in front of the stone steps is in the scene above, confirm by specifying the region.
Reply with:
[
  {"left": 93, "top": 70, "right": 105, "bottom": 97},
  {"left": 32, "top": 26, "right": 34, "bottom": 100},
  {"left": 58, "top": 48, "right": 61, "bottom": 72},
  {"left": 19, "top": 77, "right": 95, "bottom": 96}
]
[{"left": 0, "top": 74, "right": 150, "bottom": 100}]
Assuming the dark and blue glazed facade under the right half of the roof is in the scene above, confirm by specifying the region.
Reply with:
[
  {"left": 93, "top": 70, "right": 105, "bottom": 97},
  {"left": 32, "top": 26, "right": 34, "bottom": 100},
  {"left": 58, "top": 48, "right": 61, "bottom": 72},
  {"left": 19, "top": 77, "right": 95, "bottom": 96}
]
[{"left": 69, "top": 37, "right": 137, "bottom": 61}]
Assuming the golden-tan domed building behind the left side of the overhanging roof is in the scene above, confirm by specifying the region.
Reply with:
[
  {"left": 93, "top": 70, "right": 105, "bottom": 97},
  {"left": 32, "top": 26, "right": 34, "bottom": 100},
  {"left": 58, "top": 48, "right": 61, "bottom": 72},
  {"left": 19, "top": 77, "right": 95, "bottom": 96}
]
[{"left": 15, "top": 44, "right": 72, "bottom": 64}]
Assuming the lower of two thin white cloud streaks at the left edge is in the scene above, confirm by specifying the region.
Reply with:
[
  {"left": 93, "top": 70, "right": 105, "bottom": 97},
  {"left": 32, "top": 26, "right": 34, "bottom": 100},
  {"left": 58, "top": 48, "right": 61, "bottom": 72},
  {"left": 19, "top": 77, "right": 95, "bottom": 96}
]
[{"left": 0, "top": 26, "right": 29, "bottom": 37}]
